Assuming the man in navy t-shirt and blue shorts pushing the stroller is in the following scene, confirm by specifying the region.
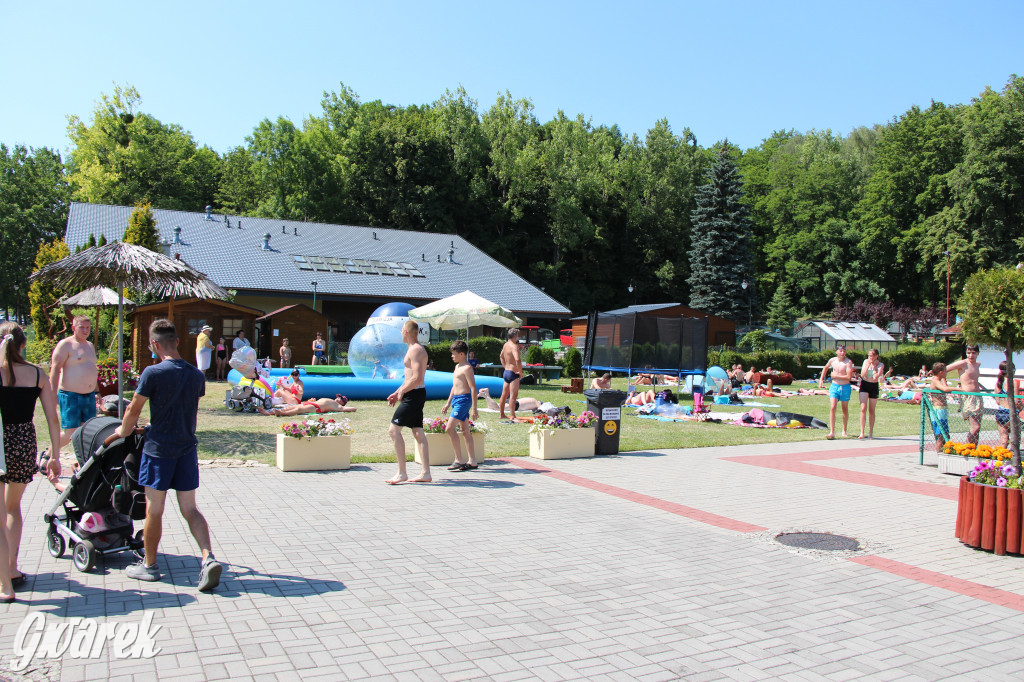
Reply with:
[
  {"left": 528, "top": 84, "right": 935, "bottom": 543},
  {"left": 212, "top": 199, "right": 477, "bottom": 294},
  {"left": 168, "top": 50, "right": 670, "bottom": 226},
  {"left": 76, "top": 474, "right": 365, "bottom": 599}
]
[{"left": 117, "top": 319, "right": 222, "bottom": 592}]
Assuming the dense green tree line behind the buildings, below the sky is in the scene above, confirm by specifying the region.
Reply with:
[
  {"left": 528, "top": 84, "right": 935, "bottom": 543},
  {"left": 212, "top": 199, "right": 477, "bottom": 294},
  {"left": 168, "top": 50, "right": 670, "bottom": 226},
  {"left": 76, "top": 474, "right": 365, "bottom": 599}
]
[{"left": 8, "top": 76, "right": 1024, "bottom": 324}]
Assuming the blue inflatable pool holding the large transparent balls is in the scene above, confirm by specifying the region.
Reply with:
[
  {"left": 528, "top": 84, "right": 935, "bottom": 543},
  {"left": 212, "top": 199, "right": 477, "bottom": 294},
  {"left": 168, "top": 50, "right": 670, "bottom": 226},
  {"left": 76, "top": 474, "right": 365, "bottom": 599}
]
[{"left": 227, "top": 368, "right": 505, "bottom": 400}]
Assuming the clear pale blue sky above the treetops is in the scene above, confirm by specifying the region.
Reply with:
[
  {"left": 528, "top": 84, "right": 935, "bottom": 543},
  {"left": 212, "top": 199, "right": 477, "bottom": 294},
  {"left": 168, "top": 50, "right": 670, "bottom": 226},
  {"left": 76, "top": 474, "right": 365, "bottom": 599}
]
[{"left": 0, "top": 0, "right": 1024, "bottom": 152}]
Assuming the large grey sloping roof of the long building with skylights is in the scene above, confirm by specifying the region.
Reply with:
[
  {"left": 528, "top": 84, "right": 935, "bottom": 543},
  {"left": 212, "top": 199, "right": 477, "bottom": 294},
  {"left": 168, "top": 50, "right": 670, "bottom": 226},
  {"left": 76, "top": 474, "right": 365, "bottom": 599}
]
[{"left": 65, "top": 202, "right": 569, "bottom": 316}]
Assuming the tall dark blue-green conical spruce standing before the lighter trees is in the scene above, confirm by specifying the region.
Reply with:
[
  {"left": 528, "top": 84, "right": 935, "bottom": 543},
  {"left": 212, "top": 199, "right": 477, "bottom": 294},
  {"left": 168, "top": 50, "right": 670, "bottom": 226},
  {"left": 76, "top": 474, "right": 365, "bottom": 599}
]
[{"left": 689, "top": 142, "right": 752, "bottom": 319}]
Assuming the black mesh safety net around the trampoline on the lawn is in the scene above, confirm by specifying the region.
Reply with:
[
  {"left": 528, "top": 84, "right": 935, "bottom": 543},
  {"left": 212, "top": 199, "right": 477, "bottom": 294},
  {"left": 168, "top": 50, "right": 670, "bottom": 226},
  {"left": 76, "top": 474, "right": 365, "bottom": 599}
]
[{"left": 583, "top": 312, "right": 708, "bottom": 375}]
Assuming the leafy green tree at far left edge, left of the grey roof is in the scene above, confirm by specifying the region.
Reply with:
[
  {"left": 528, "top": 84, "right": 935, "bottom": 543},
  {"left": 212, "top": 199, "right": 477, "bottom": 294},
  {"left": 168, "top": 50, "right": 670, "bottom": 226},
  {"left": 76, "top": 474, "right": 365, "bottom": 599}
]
[{"left": 0, "top": 144, "right": 71, "bottom": 315}]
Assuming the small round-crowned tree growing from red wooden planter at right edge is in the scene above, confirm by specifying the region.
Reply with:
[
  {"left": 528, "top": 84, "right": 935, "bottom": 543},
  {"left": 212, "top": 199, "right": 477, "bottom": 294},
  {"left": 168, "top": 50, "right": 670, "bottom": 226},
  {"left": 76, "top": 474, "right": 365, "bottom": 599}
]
[{"left": 959, "top": 268, "right": 1024, "bottom": 464}]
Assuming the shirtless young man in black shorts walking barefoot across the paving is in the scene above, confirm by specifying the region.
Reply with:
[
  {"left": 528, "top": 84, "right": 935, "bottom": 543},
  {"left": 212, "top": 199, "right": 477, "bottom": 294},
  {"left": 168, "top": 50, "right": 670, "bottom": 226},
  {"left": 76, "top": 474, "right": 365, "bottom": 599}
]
[{"left": 384, "top": 319, "right": 432, "bottom": 485}]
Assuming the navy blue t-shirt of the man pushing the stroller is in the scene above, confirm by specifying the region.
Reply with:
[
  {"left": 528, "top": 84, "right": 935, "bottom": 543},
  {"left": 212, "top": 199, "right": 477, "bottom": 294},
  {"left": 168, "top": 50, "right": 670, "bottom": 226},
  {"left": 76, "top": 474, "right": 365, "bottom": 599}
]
[{"left": 135, "top": 358, "right": 206, "bottom": 459}]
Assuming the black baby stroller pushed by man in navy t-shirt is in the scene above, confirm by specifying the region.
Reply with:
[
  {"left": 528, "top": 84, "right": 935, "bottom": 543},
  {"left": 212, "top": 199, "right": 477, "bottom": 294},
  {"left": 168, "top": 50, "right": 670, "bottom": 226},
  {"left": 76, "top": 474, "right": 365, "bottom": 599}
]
[{"left": 43, "top": 417, "right": 145, "bottom": 572}]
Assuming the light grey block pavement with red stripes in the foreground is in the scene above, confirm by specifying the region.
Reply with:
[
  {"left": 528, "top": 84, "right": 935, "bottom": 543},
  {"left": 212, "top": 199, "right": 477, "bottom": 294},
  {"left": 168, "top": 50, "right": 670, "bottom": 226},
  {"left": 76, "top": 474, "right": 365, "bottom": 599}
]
[{"left": 0, "top": 438, "right": 1024, "bottom": 681}]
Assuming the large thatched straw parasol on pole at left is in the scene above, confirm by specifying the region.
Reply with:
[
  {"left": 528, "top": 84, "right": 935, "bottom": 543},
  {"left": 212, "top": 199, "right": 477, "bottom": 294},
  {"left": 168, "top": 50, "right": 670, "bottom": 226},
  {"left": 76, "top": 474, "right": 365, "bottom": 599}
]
[{"left": 29, "top": 242, "right": 228, "bottom": 416}]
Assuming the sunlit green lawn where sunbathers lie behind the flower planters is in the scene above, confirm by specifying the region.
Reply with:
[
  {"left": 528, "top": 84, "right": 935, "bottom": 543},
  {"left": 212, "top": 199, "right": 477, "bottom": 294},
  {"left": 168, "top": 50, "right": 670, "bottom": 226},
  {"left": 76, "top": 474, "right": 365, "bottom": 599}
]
[{"left": 36, "top": 379, "right": 921, "bottom": 463}]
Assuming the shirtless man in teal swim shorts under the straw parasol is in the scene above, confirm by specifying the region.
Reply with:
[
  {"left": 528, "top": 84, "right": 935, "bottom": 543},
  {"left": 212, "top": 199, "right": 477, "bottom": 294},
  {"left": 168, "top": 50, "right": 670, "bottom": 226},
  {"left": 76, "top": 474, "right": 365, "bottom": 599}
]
[{"left": 50, "top": 315, "right": 97, "bottom": 447}]
